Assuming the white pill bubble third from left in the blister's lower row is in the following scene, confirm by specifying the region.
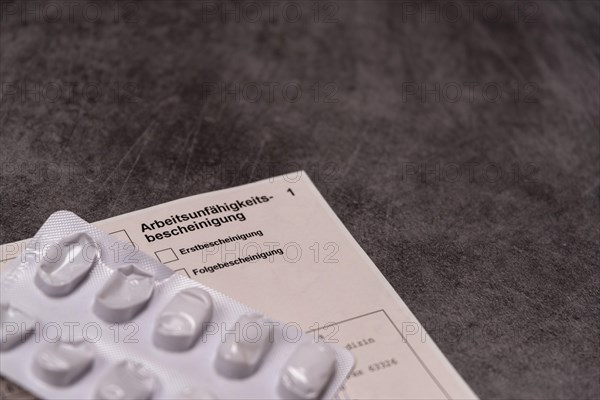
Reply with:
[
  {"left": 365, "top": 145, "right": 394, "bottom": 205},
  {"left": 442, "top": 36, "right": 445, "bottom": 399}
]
[{"left": 95, "top": 360, "right": 157, "bottom": 400}]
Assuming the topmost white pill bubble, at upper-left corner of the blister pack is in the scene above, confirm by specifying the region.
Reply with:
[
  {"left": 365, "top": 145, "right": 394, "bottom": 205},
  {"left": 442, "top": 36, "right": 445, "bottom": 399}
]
[{"left": 35, "top": 233, "right": 99, "bottom": 296}]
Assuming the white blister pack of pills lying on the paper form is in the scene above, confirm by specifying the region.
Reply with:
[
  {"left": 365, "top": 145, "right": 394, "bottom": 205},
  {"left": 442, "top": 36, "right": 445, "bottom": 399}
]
[{"left": 0, "top": 211, "right": 354, "bottom": 400}]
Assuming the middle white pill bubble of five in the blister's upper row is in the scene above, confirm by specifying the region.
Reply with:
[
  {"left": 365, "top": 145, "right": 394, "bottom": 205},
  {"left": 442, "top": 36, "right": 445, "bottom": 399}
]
[{"left": 154, "top": 288, "right": 213, "bottom": 351}]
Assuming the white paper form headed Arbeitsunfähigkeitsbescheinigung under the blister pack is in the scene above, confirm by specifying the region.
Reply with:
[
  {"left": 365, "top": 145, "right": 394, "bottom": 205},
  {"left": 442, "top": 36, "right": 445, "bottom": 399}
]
[{"left": 0, "top": 171, "right": 476, "bottom": 399}]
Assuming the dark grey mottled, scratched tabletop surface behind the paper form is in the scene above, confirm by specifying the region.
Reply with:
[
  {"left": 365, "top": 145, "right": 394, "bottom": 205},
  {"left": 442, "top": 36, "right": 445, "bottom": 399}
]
[{"left": 0, "top": 0, "right": 600, "bottom": 399}]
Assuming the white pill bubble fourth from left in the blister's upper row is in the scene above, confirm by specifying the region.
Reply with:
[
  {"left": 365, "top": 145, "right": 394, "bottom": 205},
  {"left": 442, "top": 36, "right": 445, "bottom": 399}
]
[{"left": 215, "top": 314, "right": 274, "bottom": 379}]
